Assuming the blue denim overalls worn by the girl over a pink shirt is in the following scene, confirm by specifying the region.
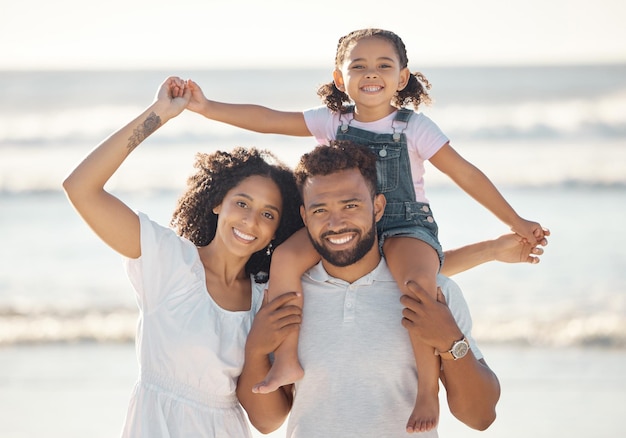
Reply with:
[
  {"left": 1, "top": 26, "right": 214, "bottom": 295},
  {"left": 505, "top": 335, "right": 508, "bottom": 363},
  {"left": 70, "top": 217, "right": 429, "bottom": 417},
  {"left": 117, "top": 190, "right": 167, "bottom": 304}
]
[{"left": 336, "top": 107, "right": 443, "bottom": 266}]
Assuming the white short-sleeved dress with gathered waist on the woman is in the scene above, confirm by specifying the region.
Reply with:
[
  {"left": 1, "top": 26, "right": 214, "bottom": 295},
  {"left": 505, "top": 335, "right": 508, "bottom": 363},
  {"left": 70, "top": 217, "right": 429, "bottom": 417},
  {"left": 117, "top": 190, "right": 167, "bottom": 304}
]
[{"left": 122, "top": 213, "right": 264, "bottom": 438}]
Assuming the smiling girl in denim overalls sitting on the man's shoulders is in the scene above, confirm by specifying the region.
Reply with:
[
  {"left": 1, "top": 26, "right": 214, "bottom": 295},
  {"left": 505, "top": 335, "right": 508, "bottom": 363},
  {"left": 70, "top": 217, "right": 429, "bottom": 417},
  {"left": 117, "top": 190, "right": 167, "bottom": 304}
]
[{"left": 188, "top": 29, "right": 544, "bottom": 432}]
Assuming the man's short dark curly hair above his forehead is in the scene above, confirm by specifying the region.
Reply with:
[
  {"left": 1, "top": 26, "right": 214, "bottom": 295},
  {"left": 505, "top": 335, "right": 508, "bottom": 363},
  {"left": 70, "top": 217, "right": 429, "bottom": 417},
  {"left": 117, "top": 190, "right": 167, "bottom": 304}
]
[{"left": 294, "top": 140, "right": 377, "bottom": 199}]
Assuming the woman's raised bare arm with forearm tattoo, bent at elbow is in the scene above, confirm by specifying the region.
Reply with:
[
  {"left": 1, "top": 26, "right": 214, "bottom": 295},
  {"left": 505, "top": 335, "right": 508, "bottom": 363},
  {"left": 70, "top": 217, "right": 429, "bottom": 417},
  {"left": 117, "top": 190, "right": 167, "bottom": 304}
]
[{"left": 63, "top": 77, "right": 191, "bottom": 258}]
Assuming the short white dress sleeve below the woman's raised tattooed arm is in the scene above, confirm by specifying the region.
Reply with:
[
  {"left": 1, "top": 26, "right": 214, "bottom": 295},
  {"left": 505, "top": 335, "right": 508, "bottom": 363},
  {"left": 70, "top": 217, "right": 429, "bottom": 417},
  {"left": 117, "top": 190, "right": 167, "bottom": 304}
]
[{"left": 124, "top": 213, "right": 198, "bottom": 312}]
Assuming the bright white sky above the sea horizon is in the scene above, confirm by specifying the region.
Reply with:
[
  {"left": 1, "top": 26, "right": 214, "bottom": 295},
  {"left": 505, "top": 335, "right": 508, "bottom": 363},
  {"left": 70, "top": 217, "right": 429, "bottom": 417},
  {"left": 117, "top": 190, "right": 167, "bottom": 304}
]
[{"left": 0, "top": 0, "right": 626, "bottom": 70}]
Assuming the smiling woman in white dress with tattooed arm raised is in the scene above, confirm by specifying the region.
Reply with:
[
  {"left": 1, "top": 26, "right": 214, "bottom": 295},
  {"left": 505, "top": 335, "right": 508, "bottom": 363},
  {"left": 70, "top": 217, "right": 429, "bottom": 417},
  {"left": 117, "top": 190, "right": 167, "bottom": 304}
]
[{"left": 63, "top": 77, "right": 302, "bottom": 438}]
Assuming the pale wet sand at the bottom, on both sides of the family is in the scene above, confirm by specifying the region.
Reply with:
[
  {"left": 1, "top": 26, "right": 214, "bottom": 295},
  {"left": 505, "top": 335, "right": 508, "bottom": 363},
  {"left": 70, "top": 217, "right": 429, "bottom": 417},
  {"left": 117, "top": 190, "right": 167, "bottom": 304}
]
[{"left": 0, "top": 343, "right": 626, "bottom": 438}]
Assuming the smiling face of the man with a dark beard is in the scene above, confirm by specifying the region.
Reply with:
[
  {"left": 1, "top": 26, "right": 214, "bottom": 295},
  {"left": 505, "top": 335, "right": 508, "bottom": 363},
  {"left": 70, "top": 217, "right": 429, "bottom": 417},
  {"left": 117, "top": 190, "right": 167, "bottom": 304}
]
[{"left": 301, "top": 169, "right": 384, "bottom": 267}]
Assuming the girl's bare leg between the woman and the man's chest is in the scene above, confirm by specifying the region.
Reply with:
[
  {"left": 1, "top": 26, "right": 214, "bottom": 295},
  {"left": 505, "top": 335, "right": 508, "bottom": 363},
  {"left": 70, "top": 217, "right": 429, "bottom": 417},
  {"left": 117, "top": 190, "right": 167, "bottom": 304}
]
[{"left": 252, "top": 228, "right": 320, "bottom": 394}]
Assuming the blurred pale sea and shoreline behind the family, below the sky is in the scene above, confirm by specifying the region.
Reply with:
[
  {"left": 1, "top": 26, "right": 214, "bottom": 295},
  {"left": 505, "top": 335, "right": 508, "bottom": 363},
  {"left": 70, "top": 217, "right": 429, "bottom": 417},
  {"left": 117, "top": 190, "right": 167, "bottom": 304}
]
[{"left": 0, "top": 65, "right": 626, "bottom": 437}]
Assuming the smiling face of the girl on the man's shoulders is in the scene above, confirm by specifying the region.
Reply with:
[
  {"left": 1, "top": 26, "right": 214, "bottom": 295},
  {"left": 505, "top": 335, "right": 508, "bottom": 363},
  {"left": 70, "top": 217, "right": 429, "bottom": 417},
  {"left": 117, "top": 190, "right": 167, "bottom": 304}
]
[{"left": 333, "top": 37, "right": 410, "bottom": 121}]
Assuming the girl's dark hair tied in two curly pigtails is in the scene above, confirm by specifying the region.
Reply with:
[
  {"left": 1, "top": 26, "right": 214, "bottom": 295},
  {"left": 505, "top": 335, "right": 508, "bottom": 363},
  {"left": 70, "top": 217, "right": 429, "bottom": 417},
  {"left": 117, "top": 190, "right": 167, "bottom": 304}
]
[{"left": 317, "top": 28, "right": 430, "bottom": 112}]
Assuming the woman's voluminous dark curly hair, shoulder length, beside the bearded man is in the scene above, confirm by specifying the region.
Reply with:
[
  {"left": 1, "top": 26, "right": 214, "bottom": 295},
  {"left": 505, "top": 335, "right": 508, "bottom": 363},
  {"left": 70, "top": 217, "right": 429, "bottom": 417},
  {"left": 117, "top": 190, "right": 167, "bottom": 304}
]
[{"left": 170, "top": 147, "right": 303, "bottom": 281}]
